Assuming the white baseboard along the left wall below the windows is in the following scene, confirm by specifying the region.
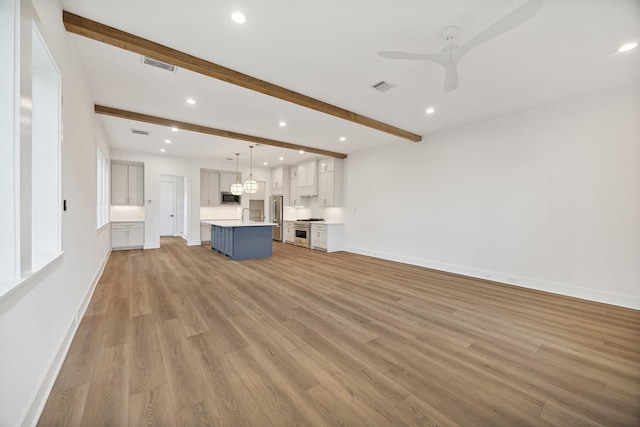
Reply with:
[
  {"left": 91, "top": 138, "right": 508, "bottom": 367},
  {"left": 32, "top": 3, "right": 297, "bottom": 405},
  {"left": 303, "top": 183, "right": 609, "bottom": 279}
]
[{"left": 20, "top": 248, "right": 111, "bottom": 426}]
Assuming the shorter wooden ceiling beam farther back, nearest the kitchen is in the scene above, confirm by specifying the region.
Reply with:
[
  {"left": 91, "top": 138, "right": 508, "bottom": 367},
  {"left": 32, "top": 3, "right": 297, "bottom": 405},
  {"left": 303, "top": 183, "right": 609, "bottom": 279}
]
[{"left": 95, "top": 105, "right": 347, "bottom": 159}]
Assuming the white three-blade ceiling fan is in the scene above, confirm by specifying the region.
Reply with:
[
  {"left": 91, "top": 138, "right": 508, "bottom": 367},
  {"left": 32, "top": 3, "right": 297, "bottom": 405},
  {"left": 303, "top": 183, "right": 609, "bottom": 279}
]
[{"left": 378, "top": 0, "right": 545, "bottom": 92}]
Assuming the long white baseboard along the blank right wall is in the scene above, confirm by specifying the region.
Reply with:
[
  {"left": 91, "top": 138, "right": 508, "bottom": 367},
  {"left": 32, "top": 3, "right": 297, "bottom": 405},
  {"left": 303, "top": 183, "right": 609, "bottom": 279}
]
[{"left": 345, "top": 247, "right": 640, "bottom": 310}]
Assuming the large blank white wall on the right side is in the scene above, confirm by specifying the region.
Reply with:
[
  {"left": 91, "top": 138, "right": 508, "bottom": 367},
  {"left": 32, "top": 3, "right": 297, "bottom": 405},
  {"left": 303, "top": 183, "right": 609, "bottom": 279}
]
[{"left": 345, "top": 85, "right": 640, "bottom": 309}]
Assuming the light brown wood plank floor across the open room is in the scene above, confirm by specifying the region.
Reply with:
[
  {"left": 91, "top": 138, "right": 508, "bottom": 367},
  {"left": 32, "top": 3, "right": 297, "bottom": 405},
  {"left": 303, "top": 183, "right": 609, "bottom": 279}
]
[{"left": 38, "top": 238, "right": 640, "bottom": 427}]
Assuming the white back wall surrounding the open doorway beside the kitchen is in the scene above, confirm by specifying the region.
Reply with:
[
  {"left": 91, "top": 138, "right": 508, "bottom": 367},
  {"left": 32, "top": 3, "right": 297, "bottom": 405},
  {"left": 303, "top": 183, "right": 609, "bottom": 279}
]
[{"left": 111, "top": 150, "right": 271, "bottom": 249}]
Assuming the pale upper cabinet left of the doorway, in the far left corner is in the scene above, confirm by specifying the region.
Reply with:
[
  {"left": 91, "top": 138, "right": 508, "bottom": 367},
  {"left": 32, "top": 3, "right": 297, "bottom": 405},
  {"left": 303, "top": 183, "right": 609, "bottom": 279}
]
[{"left": 111, "top": 161, "right": 144, "bottom": 206}]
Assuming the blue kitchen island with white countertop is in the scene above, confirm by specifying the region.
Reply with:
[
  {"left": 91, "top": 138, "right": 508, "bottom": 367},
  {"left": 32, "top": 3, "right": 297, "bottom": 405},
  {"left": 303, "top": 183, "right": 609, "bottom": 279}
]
[{"left": 200, "top": 220, "right": 273, "bottom": 261}]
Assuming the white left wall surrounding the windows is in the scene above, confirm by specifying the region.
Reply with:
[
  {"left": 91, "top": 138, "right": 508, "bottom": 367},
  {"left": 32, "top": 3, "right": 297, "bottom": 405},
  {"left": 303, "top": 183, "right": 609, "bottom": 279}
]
[{"left": 0, "top": 0, "right": 110, "bottom": 426}]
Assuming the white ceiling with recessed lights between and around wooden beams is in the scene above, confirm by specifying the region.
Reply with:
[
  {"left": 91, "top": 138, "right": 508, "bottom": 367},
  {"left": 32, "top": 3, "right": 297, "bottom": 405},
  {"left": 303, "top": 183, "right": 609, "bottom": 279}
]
[{"left": 61, "top": 0, "right": 640, "bottom": 166}]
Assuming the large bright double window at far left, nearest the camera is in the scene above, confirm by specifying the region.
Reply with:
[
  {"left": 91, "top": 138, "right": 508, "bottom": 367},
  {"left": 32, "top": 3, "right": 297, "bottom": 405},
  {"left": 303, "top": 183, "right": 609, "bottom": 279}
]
[{"left": 0, "top": 17, "right": 62, "bottom": 298}]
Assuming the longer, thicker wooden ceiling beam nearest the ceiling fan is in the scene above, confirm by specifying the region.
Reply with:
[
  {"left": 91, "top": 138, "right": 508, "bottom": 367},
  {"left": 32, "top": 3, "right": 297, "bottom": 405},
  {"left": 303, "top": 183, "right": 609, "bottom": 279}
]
[{"left": 62, "top": 11, "right": 422, "bottom": 142}]
